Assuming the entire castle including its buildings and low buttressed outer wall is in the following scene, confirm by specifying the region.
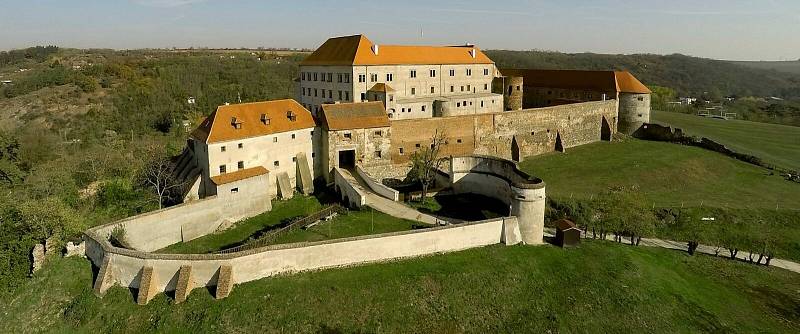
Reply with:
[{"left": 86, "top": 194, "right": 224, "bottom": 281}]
[{"left": 84, "top": 35, "right": 650, "bottom": 304}]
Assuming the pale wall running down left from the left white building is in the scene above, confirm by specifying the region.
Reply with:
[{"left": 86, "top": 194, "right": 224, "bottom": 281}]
[{"left": 95, "top": 175, "right": 272, "bottom": 252}]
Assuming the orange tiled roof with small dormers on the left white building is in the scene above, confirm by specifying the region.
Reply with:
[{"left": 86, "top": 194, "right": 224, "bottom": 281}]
[{"left": 192, "top": 99, "right": 315, "bottom": 144}]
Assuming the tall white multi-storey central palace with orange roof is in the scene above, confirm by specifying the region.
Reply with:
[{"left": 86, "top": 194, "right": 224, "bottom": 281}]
[{"left": 297, "top": 35, "right": 503, "bottom": 120}]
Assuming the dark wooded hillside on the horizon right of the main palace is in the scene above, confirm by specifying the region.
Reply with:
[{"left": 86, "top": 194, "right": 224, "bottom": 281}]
[{"left": 486, "top": 50, "right": 800, "bottom": 98}]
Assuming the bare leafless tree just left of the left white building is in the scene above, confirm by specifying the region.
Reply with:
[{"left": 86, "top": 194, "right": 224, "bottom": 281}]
[{"left": 140, "top": 146, "right": 184, "bottom": 209}]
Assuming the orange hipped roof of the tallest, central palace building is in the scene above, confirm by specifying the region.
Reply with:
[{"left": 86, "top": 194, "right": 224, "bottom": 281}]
[{"left": 300, "top": 35, "right": 494, "bottom": 65}]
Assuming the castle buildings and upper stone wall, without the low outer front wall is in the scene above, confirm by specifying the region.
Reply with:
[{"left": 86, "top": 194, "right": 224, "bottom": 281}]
[{"left": 175, "top": 35, "right": 650, "bottom": 198}]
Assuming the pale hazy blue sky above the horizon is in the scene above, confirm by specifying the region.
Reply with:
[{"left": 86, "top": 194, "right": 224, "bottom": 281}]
[{"left": 0, "top": 0, "right": 800, "bottom": 60}]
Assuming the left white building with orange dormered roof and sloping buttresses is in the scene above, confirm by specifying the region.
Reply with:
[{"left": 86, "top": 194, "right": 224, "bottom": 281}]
[{"left": 190, "top": 99, "right": 315, "bottom": 198}]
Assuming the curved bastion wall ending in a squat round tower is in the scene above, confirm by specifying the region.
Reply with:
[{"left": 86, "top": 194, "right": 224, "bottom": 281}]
[{"left": 450, "top": 155, "right": 545, "bottom": 245}]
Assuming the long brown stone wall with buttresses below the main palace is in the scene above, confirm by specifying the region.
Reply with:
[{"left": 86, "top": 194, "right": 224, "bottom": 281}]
[{"left": 391, "top": 100, "right": 619, "bottom": 163}]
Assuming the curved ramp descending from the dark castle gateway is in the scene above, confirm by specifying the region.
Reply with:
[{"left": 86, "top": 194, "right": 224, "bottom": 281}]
[{"left": 337, "top": 168, "right": 442, "bottom": 225}]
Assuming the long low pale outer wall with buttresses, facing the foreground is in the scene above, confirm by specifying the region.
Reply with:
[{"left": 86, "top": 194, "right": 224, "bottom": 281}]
[{"left": 85, "top": 217, "right": 520, "bottom": 294}]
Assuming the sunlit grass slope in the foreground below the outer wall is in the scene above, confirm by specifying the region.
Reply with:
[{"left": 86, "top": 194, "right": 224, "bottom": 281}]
[{"left": 0, "top": 241, "right": 800, "bottom": 333}]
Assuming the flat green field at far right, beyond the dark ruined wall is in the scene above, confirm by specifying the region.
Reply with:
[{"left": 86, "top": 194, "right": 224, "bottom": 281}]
[{"left": 651, "top": 111, "right": 800, "bottom": 170}]
